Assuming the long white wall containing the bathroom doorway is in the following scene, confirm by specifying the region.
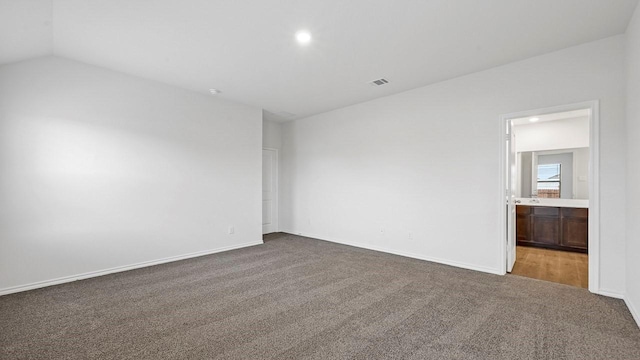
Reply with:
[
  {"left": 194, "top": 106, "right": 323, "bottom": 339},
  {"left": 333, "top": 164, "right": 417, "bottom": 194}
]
[{"left": 281, "top": 36, "right": 625, "bottom": 294}]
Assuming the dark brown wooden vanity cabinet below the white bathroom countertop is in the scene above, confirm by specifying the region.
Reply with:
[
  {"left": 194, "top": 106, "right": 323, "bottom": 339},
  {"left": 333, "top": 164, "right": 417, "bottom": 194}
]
[{"left": 516, "top": 205, "right": 589, "bottom": 253}]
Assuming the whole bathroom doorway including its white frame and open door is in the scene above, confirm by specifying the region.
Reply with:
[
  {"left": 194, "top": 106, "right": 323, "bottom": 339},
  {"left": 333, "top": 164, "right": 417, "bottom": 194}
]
[{"left": 500, "top": 101, "right": 600, "bottom": 292}]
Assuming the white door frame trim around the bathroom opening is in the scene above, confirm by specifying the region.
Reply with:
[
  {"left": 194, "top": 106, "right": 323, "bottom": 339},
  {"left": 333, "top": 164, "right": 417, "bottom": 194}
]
[{"left": 499, "top": 100, "right": 600, "bottom": 293}]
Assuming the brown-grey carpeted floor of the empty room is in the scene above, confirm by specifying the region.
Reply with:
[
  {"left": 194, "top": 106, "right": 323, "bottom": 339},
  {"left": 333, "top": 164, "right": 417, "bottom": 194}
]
[{"left": 0, "top": 234, "right": 640, "bottom": 360}]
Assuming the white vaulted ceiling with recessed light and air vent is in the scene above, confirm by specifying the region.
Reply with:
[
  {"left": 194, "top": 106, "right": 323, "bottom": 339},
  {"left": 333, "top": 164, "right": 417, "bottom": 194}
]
[{"left": 0, "top": 0, "right": 638, "bottom": 120}]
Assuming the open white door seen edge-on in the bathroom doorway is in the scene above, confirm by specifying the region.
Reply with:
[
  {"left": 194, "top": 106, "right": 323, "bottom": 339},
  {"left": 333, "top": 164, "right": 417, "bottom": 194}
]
[{"left": 506, "top": 121, "right": 518, "bottom": 272}]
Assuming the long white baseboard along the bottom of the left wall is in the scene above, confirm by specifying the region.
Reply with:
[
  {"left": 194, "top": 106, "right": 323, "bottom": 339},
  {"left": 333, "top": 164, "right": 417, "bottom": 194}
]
[{"left": 0, "top": 240, "right": 263, "bottom": 296}]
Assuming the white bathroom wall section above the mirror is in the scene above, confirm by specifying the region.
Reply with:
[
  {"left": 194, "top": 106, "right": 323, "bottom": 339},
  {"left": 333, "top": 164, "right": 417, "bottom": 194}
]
[{"left": 513, "top": 117, "right": 589, "bottom": 152}]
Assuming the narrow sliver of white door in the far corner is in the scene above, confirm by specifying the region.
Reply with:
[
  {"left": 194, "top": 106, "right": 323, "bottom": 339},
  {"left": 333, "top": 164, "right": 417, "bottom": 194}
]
[{"left": 262, "top": 149, "right": 278, "bottom": 234}]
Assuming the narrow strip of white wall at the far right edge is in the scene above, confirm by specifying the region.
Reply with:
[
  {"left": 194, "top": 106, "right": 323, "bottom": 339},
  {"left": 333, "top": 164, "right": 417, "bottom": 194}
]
[{"left": 626, "top": 7, "right": 640, "bottom": 325}]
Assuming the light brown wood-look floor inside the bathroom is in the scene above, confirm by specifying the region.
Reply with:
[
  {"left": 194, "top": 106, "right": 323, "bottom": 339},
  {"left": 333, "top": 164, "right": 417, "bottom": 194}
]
[{"left": 511, "top": 246, "right": 589, "bottom": 289}]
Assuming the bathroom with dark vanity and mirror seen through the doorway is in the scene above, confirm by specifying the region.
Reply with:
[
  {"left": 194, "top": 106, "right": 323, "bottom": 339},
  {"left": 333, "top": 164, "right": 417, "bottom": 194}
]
[{"left": 511, "top": 109, "right": 591, "bottom": 288}]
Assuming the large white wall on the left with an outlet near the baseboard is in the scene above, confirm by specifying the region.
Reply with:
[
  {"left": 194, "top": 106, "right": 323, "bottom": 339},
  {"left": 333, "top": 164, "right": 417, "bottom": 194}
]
[{"left": 0, "top": 57, "right": 262, "bottom": 292}]
